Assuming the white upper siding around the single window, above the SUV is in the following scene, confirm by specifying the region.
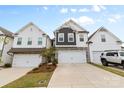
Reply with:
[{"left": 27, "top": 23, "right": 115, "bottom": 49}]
[{"left": 90, "top": 32, "right": 121, "bottom": 51}]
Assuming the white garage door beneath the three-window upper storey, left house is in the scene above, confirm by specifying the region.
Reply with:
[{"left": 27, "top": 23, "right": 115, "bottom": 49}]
[{"left": 13, "top": 54, "right": 42, "bottom": 67}]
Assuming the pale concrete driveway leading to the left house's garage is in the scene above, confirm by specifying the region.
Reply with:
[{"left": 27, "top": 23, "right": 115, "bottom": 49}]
[{"left": 0, "top": 68, "right": 32, "bottom": 87}]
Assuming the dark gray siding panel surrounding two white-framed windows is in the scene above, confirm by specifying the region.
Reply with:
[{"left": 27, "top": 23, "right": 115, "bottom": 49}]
[{"left": 56, "top": 28, "right": 76, "bottom": 45}]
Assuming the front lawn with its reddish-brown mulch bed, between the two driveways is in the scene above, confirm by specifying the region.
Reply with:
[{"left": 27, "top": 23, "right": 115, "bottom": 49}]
[{"left": 2, "top": 65, "right": 56, "bottom": 88}]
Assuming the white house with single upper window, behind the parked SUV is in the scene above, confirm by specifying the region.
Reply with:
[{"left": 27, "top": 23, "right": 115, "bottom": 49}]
[{"left": 88, "top": 27, "right": 122, "bottom": 63}]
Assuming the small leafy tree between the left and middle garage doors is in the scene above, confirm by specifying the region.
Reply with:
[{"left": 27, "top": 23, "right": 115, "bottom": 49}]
[{"left": 41, "top": 47, "right": 55, "bottom": 64}]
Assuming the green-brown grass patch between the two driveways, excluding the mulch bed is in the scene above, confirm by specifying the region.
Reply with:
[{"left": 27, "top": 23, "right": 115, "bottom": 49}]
[{"left": 2, "top": 72, "right": 53, "bottom": 88}]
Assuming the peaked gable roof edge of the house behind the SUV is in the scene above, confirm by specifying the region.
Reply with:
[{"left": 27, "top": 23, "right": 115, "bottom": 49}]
[{"left": 88, "top": 26, "right": 122, "bottom": 42}]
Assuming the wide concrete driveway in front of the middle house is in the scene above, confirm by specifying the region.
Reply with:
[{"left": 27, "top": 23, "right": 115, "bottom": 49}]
[{"left": 48, "top": 64, "right": 124, "bottom": 88}]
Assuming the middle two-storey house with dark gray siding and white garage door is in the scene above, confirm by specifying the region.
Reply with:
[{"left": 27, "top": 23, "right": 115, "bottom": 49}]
[{"left": 54, "top": 20, "right": 89, "bottom": 63}]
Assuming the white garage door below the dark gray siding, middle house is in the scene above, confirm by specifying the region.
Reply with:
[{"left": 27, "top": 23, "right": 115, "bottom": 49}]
[{"left": 58, "top": 50, "right": 86, "bottom": 63}]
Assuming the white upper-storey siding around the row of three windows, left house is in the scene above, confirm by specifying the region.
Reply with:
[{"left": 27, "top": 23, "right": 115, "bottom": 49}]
[{"left": 13, "top": 25, "right": 50, "bottom": 48}]
